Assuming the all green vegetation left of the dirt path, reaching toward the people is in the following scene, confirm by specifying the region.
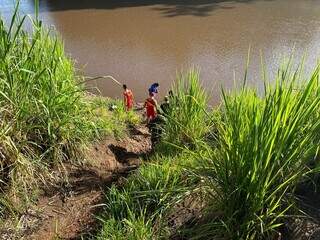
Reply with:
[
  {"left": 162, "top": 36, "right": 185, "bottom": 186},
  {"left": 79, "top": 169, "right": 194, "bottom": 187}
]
[{"left": 0, "top": 2, "right": 139, "bottom": 218}]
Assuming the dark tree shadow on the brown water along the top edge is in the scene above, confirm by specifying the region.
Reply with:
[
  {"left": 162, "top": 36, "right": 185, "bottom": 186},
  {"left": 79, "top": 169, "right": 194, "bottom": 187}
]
[{"left": 35, "top": 0, "right": 273, "bottom": 17}]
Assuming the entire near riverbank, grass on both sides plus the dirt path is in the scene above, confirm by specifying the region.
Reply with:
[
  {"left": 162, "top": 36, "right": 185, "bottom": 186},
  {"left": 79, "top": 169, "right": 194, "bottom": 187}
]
[{"left": 0, "top": 3, "right": 320, "bottom": 240}]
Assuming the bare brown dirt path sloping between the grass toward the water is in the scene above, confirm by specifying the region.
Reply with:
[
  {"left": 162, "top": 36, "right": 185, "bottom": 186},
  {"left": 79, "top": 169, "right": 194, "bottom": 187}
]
[{"left": 0, "top": 123, "right": 151, "bottom": 240}]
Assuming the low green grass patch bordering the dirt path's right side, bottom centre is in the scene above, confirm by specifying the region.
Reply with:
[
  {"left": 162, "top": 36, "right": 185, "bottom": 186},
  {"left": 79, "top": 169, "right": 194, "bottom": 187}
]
[{"left": 98, "top": 157, "right": 194, "bottom": 239}]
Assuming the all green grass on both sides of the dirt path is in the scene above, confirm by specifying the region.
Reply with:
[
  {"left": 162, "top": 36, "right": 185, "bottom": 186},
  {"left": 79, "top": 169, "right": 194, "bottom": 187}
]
[{"left": 0, "top": 2, "right": 320, "bottom": 240}]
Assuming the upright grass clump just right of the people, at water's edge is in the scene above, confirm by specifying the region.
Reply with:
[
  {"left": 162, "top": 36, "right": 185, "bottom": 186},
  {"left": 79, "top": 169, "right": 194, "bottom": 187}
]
[{"left": 162, "top": 69, "right": 211, "bottom": 151}]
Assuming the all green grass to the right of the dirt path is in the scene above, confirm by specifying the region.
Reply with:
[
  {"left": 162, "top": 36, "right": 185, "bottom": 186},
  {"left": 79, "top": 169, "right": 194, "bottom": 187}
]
[{"left": 99, "top": 63, "right": 320, "bottom": 240}]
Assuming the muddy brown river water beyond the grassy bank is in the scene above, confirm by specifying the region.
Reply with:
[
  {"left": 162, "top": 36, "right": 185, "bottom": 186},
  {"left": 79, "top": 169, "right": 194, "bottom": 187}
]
[{"left": 0, "top": 0, "right": 320, "bottom": 103}]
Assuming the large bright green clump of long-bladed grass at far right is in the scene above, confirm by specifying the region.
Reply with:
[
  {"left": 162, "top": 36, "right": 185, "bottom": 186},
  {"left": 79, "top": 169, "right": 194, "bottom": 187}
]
[{"left": 190, "top": 64, "right": 320, "bottom": 240}]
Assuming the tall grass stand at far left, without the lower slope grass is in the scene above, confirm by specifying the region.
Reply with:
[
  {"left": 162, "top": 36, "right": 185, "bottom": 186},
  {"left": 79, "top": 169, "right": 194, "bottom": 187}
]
[{"left": 0, "top": 2, "right": 82, "bottom": 191}]
